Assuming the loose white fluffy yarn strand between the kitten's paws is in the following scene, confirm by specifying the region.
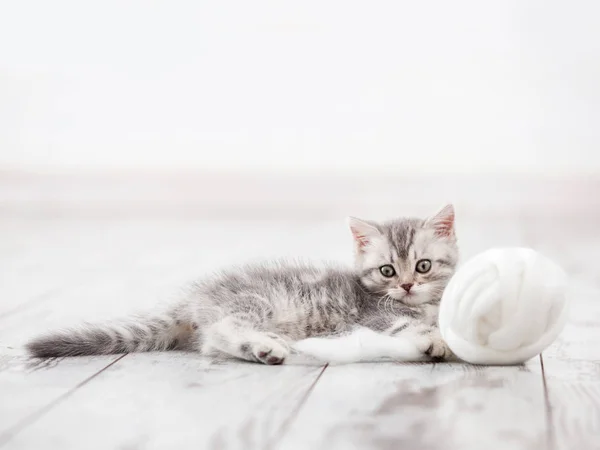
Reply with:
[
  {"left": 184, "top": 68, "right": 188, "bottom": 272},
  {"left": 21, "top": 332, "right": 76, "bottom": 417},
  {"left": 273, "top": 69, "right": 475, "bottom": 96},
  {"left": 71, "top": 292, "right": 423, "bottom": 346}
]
[{"left": 293, "top": 327, "right": 428, "bottom": 364}]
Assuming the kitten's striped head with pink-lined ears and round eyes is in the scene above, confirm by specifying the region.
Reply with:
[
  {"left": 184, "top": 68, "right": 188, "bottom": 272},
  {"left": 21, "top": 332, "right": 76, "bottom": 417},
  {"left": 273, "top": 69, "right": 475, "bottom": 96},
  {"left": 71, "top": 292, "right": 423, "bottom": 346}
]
[{"left": 349, "top": 205, "right": 458, "bottom": 306}]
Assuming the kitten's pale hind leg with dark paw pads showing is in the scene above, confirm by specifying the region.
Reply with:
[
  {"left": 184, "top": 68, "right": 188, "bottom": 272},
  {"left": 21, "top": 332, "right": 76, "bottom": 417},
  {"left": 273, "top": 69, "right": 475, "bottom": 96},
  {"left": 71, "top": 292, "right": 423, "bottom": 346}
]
[{"left": 202, "top": 314, "right": 289, "bottom": 365}]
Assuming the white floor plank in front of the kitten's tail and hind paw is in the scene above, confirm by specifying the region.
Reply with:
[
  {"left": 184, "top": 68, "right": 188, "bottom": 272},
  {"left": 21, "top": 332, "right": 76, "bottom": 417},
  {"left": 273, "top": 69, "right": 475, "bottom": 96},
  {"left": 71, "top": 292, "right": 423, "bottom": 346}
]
[{"left": 3, "top": 352, "right": 322, "bottom": 450}]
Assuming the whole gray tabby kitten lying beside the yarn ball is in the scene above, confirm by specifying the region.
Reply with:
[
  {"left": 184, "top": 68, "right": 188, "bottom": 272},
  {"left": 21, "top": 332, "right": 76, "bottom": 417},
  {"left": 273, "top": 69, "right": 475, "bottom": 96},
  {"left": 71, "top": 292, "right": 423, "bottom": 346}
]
[{"left": 27, "top": 205, "right": 458, "bottom": 364}]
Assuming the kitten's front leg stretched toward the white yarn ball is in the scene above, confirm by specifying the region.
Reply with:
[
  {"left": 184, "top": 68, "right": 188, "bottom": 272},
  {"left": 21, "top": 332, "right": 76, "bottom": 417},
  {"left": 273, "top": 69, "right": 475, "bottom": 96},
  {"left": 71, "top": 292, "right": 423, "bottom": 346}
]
[{"left": 386, "top": 317, "right": 454, "bottom": 360}]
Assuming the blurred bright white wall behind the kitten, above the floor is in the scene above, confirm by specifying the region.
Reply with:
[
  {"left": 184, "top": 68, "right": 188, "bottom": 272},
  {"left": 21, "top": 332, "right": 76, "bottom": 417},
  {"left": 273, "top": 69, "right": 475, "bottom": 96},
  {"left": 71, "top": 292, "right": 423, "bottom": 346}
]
[{"left": 0, "top": 0, "right": 600, "bottom": 173}]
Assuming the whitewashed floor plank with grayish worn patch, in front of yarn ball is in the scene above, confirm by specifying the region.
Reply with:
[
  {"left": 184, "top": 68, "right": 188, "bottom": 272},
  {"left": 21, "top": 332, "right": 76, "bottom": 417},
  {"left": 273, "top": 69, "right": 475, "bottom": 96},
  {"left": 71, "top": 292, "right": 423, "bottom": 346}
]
[{"left": 278, "top": 363, "right": 547, "bottom": 450}]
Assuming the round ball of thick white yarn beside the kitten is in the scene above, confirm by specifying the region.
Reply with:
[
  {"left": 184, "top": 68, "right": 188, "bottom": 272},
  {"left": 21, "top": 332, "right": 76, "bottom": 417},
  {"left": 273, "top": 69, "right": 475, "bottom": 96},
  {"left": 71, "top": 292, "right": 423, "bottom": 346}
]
[{"left": 439, "top": 248, "right": 568, "bottom": 364}]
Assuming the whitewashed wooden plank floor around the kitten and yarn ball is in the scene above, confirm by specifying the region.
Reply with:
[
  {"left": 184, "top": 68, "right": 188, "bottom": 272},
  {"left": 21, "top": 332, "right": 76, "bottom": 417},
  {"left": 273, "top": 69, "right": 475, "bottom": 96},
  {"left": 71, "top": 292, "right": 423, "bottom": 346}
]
[{"left": 0, "top": 216, "right": 600, "bottom": 450}]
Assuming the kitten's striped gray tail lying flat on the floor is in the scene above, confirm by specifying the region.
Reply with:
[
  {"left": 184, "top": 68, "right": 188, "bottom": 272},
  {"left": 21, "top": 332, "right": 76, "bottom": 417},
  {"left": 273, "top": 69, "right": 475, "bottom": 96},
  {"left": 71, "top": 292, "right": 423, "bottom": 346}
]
[{"left": 26, "top": 314, "right": 192, "bottom": 358}]
